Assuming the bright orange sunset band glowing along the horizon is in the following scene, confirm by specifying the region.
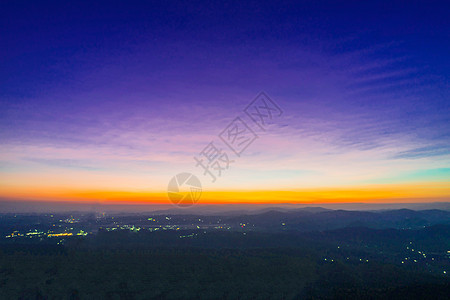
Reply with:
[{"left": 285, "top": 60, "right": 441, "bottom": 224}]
[{"left": 0, "top": 182, "right": 450, "bottom": 204}]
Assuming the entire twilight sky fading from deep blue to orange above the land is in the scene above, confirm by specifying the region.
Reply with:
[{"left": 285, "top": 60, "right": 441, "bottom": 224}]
[{"left": 0, "top": 1, "right": 450, "bottom": 203}]
